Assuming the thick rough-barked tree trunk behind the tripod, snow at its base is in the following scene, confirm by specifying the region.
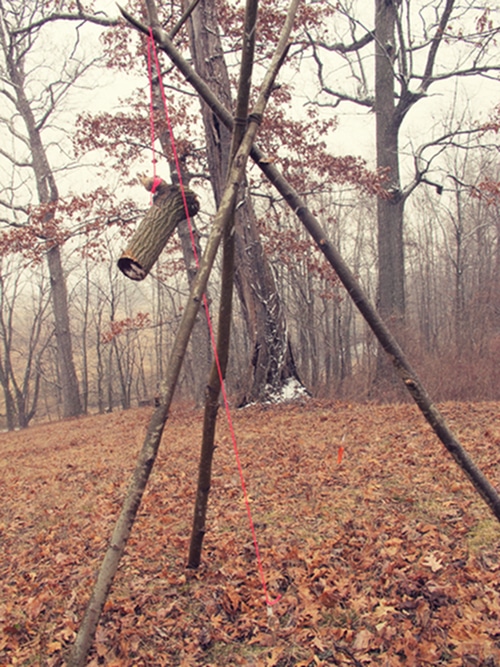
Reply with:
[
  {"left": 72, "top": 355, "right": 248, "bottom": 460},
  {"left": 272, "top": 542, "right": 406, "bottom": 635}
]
[{"left": 190, "top": 0, "right": 297, "bottom": 405}]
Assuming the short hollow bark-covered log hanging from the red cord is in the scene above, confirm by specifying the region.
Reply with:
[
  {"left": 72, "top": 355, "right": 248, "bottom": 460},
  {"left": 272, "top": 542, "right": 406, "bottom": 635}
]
[{"left": 118, "top": 177, "right": 200, "bottom": 280}]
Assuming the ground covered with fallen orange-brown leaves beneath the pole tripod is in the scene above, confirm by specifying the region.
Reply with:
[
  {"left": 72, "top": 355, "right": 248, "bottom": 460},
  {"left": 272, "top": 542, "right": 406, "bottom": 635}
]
[{"left": 0, "top": 401, "right": 500, "bottom": 667}]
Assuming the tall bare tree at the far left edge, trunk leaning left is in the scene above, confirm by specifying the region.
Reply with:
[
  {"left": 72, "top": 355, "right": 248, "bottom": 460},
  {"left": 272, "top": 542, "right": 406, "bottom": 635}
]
[{"left": 0, "top": 0, "right": 95, "bottom": 417}]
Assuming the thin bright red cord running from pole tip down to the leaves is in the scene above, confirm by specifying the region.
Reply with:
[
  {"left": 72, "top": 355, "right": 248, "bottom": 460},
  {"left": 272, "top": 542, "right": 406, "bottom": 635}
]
[{"left": 148, "top": 28, "right": 281, "bottom": 607}]
